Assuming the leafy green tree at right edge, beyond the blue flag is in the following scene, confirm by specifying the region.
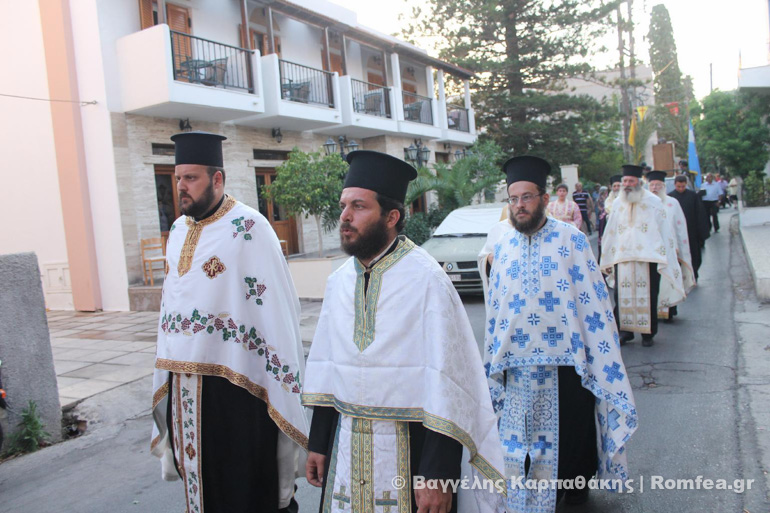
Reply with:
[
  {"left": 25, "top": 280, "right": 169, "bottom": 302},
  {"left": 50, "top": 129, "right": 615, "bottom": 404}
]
[{"left": 693, "top": 91, "right": 770, "bottom": 178}]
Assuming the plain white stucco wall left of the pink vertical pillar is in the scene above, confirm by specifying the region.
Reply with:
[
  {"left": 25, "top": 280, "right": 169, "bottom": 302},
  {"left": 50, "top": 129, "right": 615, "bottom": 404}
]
[{"left": 0, "top": 1, "right": 72, "bottom": 309}]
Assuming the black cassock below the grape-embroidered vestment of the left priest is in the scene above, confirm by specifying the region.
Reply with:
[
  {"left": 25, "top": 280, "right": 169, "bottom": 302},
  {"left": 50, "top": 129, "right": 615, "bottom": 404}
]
[{"left": 166, "top": 373, "right": 298, "bottom": 513}]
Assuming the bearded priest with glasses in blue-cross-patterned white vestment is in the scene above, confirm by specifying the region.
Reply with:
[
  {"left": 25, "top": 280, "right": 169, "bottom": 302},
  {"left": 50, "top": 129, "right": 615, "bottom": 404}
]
[{"left": 482, "top": 156, "right": 637, "bottom": 513}]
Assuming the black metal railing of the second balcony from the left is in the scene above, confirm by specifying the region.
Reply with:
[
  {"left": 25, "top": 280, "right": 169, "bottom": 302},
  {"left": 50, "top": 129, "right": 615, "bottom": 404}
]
[{"left": 278, "top": 59, "right": 334, "bottom": 108}]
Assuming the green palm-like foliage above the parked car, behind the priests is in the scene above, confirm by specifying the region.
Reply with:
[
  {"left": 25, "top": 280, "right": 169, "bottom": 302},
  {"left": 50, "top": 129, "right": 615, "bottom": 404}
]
[{"left": 406, "top": 140, "right": 504, "bottom": 211}]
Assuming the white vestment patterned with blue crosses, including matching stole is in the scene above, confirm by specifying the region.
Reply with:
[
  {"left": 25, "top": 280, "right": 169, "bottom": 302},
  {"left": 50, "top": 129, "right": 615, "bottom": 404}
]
[{"left": 484, "top": 218, "right": 637, "bottom": 513}]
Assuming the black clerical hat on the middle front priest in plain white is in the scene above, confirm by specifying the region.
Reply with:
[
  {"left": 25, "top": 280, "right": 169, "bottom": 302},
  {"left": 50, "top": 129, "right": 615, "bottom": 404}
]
[{"left": 343, "top": 150, "right": 417, "bottom": 203}]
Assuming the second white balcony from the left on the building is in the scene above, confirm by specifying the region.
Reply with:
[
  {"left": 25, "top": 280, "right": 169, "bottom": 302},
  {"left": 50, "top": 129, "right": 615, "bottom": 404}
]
[{"left": 235, "top": 54, "right": 342, "bottom": 131}]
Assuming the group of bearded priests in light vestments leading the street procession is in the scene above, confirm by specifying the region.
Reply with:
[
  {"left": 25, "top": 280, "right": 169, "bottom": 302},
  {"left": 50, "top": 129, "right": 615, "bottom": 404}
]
[{"left": 151, "top": 132, "right": 695, "bottom": 513}]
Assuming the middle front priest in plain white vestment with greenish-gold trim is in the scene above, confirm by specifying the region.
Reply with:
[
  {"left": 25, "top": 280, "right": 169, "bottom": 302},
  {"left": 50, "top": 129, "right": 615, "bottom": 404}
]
[{"left": 302, "top": 151, "right": 505, "bottom": 513}]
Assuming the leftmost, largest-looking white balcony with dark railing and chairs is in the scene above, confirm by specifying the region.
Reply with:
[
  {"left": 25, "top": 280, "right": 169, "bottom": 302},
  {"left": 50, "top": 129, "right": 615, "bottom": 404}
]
[{"left": 117, "top": 24, "right": 264, "bottom": 123}]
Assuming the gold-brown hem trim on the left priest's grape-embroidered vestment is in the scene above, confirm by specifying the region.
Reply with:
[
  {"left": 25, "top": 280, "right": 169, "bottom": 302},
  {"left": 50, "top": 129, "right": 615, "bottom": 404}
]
[{"left": 155, "top": 358, "right": 307, "bottom": 450}]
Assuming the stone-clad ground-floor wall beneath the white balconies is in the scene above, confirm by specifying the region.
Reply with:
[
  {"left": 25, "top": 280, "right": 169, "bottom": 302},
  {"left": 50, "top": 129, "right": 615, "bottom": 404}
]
[{"left": 112, "top": 113, "right": 436, "bottom": 284}]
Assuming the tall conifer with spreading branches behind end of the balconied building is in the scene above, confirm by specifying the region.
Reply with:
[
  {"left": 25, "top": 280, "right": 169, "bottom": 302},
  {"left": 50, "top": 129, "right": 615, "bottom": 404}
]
[{"left": 402, "top": 0, "right": 617, "bottom": 165}]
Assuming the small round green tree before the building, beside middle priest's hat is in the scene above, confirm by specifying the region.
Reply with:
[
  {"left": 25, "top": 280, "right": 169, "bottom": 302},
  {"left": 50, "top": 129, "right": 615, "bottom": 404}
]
[{"left": 264, "top": 148, "right": 348, "bottom": 257}]
